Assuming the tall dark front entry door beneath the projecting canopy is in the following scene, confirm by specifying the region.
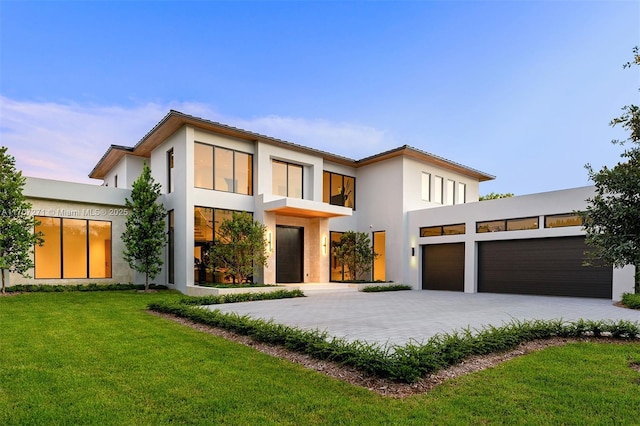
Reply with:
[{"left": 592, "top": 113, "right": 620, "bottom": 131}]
[{"left": 276, "top": 226, "right": 304, "bottom": 283}]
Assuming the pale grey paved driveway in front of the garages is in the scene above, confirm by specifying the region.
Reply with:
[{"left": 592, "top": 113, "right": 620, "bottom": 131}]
[{"left": 209, "top": 285, "right": 640, "bottom": 345}]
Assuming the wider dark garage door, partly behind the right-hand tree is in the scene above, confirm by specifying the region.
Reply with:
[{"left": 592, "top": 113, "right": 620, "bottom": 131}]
[{"left": 478, "top": 236, "right": 613, "bottom": 299}]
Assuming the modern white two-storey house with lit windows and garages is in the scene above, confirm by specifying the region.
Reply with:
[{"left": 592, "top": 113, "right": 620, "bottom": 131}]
[{"left": 11, "top": 111, "right": 633, "bottom": 300}]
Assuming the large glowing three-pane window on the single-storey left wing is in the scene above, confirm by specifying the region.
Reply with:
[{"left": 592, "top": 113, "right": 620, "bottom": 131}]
[{"left": 35, "top": 216, "right": 111, "bottom": 279}]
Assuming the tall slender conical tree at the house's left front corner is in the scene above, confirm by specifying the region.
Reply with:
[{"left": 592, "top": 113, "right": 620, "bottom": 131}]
[{"left": 122, "top": 163, "right": 167, "bottom": 290}]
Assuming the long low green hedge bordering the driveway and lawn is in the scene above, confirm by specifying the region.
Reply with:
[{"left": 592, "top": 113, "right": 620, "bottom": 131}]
[{"left": 149, "top": 293, "right": 640, "bottom": 383}]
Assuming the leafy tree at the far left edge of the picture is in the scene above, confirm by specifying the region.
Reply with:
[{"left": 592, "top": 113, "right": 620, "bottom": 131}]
[{"left": 0, "top": 146, "right": 44, "bottom": 294}]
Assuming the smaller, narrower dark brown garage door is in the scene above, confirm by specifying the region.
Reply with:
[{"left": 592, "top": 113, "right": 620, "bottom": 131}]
[{"left": 422, "top": 243, "right": 464, "bottom": 291}]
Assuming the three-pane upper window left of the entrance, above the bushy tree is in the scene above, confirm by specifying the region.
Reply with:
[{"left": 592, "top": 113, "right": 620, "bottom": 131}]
[{"left": 194, "top": 142, "right": 253, "bottom": 195}]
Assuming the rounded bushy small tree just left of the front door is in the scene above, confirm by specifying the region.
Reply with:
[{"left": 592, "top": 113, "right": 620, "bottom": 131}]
[{"left": 209, "top": 212, "right": 267, "bottom": 284}]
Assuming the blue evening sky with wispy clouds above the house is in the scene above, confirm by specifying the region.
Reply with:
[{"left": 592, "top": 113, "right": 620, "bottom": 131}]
[{"left": 0, "top": 0, "right": 640, "bottom": 195}]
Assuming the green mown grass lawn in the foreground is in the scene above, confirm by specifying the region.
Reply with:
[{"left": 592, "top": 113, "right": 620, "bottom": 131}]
[{"left": 0, "top": 291, "right": 640, "bottom": 425}]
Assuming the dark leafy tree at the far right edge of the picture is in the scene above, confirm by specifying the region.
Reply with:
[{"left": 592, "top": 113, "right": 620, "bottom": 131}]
[{"left": 581, "top": 47, "right": 640, "bottom": 293}]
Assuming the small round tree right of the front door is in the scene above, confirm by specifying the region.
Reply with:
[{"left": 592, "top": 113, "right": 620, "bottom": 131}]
[{"left": 332, "top": 231, "right": 378, "bottom": 281}]
